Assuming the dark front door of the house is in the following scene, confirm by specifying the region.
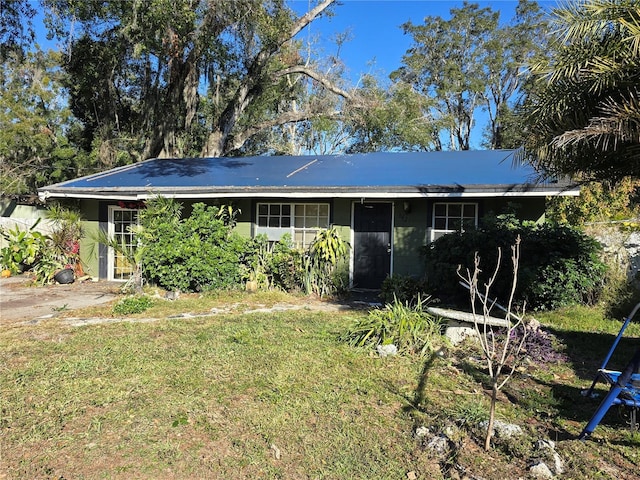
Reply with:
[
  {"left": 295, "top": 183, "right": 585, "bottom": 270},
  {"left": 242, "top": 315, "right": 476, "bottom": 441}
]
[{"left": 353, "top": 202, "right": 392, "bottom": 289}]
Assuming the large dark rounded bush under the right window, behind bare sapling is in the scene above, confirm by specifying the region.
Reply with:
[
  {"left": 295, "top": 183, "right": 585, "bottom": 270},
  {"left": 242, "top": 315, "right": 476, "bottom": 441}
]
[{"left": 425, "top": 216, "right": 606, "bottom": 310}]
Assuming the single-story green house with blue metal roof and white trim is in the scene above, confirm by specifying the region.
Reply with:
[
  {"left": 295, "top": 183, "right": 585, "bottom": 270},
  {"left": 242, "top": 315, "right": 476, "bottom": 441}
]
[{"left": 38, "top": 150, "right": 579, "bottom": 288}]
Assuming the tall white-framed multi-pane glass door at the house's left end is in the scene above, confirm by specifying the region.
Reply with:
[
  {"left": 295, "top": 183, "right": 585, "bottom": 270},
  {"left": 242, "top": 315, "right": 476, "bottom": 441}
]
[{"left": 108, "top": 206, "right": 138, "bottom": 280}]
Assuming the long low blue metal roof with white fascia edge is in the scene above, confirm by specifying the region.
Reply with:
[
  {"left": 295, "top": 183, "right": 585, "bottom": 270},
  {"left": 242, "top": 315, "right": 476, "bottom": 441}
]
[{"left": 39, "top": 150, "right": 580, "bottom": 198}]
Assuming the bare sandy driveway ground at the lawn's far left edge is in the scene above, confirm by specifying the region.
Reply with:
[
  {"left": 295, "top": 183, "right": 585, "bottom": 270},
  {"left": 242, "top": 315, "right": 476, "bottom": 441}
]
[{"left": 0, "top": 275, "right": 120, "bottom": 325}]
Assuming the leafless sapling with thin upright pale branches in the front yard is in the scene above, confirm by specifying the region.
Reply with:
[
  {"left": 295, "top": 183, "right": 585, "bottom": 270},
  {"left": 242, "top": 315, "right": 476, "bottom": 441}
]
[{"left": 458, "top": 236, "right": 527, "bottom": 450}]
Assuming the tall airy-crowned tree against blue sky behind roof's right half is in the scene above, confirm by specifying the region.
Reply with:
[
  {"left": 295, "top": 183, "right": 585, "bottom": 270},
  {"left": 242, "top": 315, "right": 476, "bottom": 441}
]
[{"left": 391, "top": 0, "right": 544, "bottom": 150}]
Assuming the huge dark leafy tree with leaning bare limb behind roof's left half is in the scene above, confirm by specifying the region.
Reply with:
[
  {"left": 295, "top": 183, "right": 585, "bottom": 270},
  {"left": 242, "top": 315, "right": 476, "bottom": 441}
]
[{"left": 48, "top": 0, "right": 351, "bottom": 159}]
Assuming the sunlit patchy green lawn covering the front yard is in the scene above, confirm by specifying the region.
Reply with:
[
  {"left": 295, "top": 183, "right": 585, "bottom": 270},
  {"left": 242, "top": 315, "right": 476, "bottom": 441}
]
[{"left": 0, "top": 293, "right": 640, "bottom": 479}]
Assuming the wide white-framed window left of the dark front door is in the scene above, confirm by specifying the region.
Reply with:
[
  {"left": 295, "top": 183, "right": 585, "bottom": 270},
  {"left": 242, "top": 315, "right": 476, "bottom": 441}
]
[{"left": 255, "top": 203, "right": 329, "bottom": 248}]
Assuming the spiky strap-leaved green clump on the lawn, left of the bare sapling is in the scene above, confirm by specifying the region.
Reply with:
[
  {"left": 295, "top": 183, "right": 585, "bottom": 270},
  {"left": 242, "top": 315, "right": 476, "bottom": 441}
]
[{"left": 342, "top": 297, "right": 444, "bottom": 356}]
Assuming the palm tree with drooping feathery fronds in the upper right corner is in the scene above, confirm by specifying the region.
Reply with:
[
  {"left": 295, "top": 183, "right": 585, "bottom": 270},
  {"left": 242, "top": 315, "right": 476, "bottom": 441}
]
[{"left": 524, "top": 0, "right": 640, "bottom": 181}]
